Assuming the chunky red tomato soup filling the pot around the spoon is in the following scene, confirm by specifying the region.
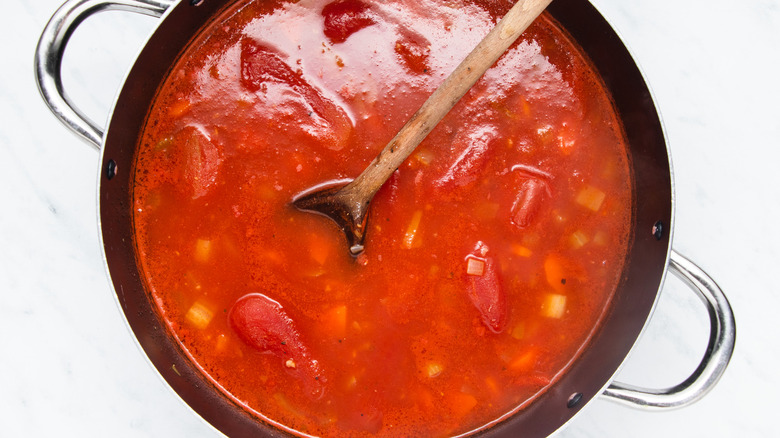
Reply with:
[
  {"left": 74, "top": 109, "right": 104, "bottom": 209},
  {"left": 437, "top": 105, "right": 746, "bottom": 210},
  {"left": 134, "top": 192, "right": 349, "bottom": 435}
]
[{"left": 133, "top": 0, "right": 632, "bottom": 437}]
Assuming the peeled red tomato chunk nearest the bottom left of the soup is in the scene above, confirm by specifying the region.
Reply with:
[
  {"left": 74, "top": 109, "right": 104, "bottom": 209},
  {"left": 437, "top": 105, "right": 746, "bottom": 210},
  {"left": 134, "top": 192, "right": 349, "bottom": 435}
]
[{"left": 228, "top": 293, "right": 324, "bottom": 398}]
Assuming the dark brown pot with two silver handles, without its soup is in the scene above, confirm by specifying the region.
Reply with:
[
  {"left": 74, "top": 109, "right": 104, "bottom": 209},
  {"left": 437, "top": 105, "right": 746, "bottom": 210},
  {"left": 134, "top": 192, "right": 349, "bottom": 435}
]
[{"left": 35, "top": 0, "right": 736, "bottom": 436}]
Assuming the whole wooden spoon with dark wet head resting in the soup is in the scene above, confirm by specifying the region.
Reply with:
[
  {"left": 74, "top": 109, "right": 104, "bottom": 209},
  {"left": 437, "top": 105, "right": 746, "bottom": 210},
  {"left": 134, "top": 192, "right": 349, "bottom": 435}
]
[{"left": 292, "top": 0, "right": 552, "bottom": 256}]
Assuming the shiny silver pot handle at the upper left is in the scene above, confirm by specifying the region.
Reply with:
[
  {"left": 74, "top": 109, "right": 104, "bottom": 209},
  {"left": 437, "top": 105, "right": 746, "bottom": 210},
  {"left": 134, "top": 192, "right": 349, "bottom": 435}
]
[{"left": 35, "top": 0, "right": 175, "bottom": 150}]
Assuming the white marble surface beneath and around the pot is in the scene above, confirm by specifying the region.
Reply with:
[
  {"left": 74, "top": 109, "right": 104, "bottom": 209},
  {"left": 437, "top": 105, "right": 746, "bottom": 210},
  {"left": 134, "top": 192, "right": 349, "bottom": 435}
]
[{"left": 0, "top": 0, "right": 780, "bottom": 437}]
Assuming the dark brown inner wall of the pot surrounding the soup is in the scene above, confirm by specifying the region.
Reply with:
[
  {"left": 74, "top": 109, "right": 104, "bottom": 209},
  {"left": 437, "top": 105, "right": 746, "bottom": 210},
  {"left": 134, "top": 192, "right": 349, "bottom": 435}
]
[{"left": 100, "top": 0, "right": 672, "bottom": 436}]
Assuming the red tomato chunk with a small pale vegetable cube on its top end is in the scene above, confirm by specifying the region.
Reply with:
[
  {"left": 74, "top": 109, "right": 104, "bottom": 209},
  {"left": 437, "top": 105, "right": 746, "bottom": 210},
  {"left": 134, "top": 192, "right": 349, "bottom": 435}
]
[{"left": 466, "top": 242, "right": 507, "bottom": 333}]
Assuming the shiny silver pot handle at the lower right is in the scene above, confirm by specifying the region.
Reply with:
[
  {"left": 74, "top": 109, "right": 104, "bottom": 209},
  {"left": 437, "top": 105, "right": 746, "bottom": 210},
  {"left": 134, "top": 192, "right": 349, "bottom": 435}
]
[{"left": 602, "top": 250, "right": 737, "bottom": 410}]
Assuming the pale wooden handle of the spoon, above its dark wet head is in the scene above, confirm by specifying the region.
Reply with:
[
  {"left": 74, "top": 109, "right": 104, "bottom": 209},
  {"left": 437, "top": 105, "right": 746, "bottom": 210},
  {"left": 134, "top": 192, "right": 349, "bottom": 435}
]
[{"left": 349, "top": 0, "right": 552, "bottom": 199}]
